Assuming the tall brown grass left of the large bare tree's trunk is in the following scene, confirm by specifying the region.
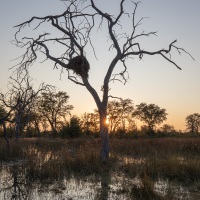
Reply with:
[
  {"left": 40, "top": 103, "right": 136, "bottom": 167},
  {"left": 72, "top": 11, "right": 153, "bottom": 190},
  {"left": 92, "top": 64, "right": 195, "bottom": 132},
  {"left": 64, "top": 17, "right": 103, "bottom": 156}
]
[{"left": 0, "top": 139, "right": 114, "bottom": 180}]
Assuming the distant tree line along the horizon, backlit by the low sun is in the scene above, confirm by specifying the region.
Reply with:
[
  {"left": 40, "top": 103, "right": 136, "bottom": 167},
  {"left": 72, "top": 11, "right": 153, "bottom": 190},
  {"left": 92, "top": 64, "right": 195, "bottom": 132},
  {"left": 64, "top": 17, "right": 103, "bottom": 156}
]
[{"left": 0, "top": 73, "right": 200, "bottom": 141}]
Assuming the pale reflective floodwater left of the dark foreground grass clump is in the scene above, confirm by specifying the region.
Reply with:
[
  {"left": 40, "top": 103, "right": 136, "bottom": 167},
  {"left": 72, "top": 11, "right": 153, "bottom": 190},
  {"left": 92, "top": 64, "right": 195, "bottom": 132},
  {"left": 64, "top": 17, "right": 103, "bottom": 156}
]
[{"left": 0, "top": 164, "right": 128, "bottom": 200}]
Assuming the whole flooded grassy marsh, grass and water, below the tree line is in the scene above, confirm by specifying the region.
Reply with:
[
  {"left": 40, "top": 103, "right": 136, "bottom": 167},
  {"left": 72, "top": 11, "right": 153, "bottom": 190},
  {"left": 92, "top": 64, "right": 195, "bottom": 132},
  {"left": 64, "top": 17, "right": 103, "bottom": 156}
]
[{"left": 0, "top": 138, "right": 200, "bottom": 200}]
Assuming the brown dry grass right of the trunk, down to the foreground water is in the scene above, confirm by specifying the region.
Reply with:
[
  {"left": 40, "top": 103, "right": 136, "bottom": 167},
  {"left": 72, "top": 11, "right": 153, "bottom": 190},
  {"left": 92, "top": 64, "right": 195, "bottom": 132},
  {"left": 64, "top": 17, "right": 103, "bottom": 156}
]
[{"left": 111, "top": 138, "right": 200, "bottom": 186}]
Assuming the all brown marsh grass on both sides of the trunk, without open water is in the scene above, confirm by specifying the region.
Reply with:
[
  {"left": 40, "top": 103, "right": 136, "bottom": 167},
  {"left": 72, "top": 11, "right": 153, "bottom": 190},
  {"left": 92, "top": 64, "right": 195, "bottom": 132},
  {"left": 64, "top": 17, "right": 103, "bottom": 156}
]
[{"left": 0, "top": 138, "right": 200, "bottom": 200}]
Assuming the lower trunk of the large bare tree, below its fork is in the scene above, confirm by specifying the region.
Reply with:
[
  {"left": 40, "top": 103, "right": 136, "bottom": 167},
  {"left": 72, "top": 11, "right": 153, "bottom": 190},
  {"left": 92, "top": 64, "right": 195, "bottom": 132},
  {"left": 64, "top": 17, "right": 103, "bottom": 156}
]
[{"left": 100, "top": 112, "right": 109, "bottom": 161}]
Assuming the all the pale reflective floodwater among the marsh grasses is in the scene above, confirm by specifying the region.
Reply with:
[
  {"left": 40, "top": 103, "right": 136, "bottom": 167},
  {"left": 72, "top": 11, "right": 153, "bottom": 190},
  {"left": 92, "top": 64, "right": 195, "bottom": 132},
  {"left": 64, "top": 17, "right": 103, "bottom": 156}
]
[{"left": 0, "top": 155, "right": 200, "bottom": 200}]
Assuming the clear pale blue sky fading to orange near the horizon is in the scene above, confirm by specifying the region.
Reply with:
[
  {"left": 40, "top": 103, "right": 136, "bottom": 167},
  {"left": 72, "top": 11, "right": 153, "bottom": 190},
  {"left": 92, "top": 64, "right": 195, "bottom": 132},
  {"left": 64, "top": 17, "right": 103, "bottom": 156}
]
[{"left": 0, "top": 0, "right": 200, "bottom": 130}]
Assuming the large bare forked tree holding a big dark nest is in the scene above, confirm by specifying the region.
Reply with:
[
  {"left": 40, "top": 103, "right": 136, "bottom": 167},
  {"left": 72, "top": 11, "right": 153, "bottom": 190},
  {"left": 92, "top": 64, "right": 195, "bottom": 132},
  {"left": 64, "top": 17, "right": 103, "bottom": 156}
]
[{"left": 15, "top": 0, "right": 192, "bottom": 160}]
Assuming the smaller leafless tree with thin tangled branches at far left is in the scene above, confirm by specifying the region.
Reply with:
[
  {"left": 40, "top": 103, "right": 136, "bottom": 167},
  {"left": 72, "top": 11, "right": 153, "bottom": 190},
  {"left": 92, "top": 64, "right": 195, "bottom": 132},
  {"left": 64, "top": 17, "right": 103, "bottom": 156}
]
[{"left": 0, "top": 71, "right": 52, "bottom": 139}]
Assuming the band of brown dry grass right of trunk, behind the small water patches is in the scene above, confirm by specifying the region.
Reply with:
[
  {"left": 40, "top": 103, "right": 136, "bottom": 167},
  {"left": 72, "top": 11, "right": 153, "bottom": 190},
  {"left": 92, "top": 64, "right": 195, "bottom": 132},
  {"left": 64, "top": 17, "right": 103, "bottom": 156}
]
[{"left": 111, "top": 138, "right": 200, "bottom": 157}]
